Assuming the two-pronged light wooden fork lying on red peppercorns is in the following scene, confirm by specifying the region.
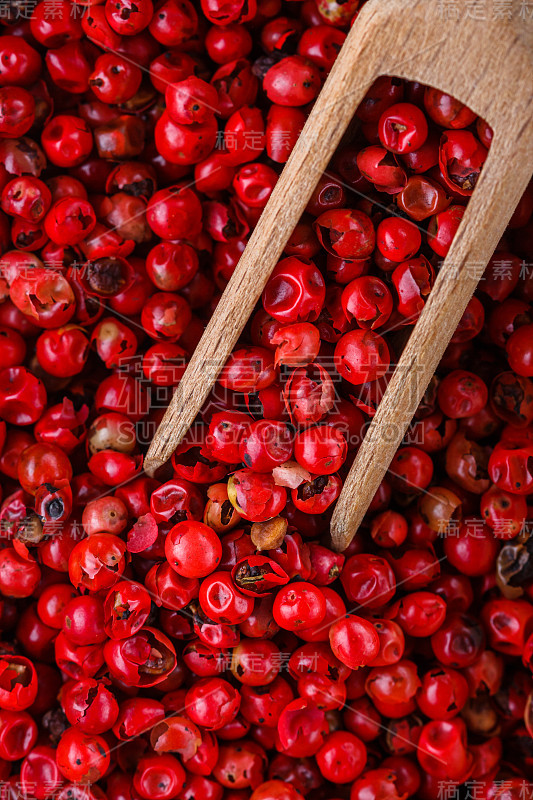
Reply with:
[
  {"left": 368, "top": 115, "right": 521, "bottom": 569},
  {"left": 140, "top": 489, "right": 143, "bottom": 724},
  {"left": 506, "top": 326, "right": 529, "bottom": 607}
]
[{"left": 145, "top": 0, "right": 533, "bottom": 551}]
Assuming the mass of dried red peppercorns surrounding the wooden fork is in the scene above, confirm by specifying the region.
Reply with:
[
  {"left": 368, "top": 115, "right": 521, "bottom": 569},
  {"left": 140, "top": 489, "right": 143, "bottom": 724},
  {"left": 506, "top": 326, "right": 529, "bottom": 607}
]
[{"left": 0, "top": 0, "right": 533, "bottom": 800}]
